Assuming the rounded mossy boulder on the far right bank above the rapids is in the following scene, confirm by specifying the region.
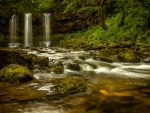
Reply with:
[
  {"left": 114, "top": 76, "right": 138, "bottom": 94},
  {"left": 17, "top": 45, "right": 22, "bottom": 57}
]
[{"left": 117, "top": 50, "right": 141, "bottom": 63}]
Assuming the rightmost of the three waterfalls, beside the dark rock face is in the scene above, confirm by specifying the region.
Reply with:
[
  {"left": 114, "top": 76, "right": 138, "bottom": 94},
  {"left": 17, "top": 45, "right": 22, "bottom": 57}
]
[{"left": 43, "top": 13, "right": 51, "bottom": 47}]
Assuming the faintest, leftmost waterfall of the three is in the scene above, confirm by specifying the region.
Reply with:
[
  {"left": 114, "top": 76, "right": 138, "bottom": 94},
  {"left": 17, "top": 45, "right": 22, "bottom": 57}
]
[{"left": 9, "top": 15, "right": 19, "bottom": 47}]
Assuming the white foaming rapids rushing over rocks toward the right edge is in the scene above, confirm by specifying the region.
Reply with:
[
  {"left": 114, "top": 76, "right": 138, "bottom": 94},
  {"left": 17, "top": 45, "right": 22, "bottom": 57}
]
[{"left": 28, "top": 49, "right": 150, "bottom": 78}]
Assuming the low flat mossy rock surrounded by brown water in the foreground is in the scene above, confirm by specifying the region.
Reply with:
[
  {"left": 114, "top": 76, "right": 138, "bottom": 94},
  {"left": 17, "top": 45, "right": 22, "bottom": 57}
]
[{"left": 52, "top": 77, "right": 87, "bottom": 94}]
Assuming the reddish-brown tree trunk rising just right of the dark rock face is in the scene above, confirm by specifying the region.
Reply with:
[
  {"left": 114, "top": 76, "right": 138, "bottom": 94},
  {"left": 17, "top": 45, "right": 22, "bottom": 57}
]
[{"left": 100, "top": 0, "right": 108, "bottom": 30}]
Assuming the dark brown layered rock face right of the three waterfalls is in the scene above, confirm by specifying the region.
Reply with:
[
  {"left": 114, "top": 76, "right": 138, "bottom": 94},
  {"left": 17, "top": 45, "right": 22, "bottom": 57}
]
[{"left": 52, "top": 12, "right": 98, "bottom": 34}]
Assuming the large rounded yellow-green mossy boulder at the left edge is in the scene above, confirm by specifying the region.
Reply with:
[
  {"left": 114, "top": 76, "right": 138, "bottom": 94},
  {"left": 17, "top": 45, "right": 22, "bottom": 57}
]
[{"left": 0, "top": 64, "right": 34, "bottom": 82}]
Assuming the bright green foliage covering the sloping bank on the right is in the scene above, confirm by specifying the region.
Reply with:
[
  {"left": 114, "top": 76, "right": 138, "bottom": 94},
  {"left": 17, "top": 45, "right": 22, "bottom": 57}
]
[{"left": 56, "top": 2, "right": 150, "bottom": 48}]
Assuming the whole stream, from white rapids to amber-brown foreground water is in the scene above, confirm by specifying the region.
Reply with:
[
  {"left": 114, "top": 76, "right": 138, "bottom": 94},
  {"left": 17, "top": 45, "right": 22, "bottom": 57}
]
[{"left": 0, "top": 48, "right": 150, "bottom": 113}]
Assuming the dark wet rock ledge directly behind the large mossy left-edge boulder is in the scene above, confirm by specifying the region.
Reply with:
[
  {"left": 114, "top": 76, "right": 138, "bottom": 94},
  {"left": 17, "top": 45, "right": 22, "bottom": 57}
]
[{"left": 0, "top": 49, "right": 35, "bottom": 69}]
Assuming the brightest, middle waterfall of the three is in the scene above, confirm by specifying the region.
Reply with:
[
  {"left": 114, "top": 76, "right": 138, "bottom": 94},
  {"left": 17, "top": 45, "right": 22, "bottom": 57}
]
[{"left": 24, "top": 13, "right": 33, "bottom": 47}]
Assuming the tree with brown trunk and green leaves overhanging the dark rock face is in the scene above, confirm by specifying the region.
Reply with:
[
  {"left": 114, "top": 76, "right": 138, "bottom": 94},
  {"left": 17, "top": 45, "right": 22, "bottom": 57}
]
[{"left": 62, "top": 0, "right": 107, "bottom": 30}]
